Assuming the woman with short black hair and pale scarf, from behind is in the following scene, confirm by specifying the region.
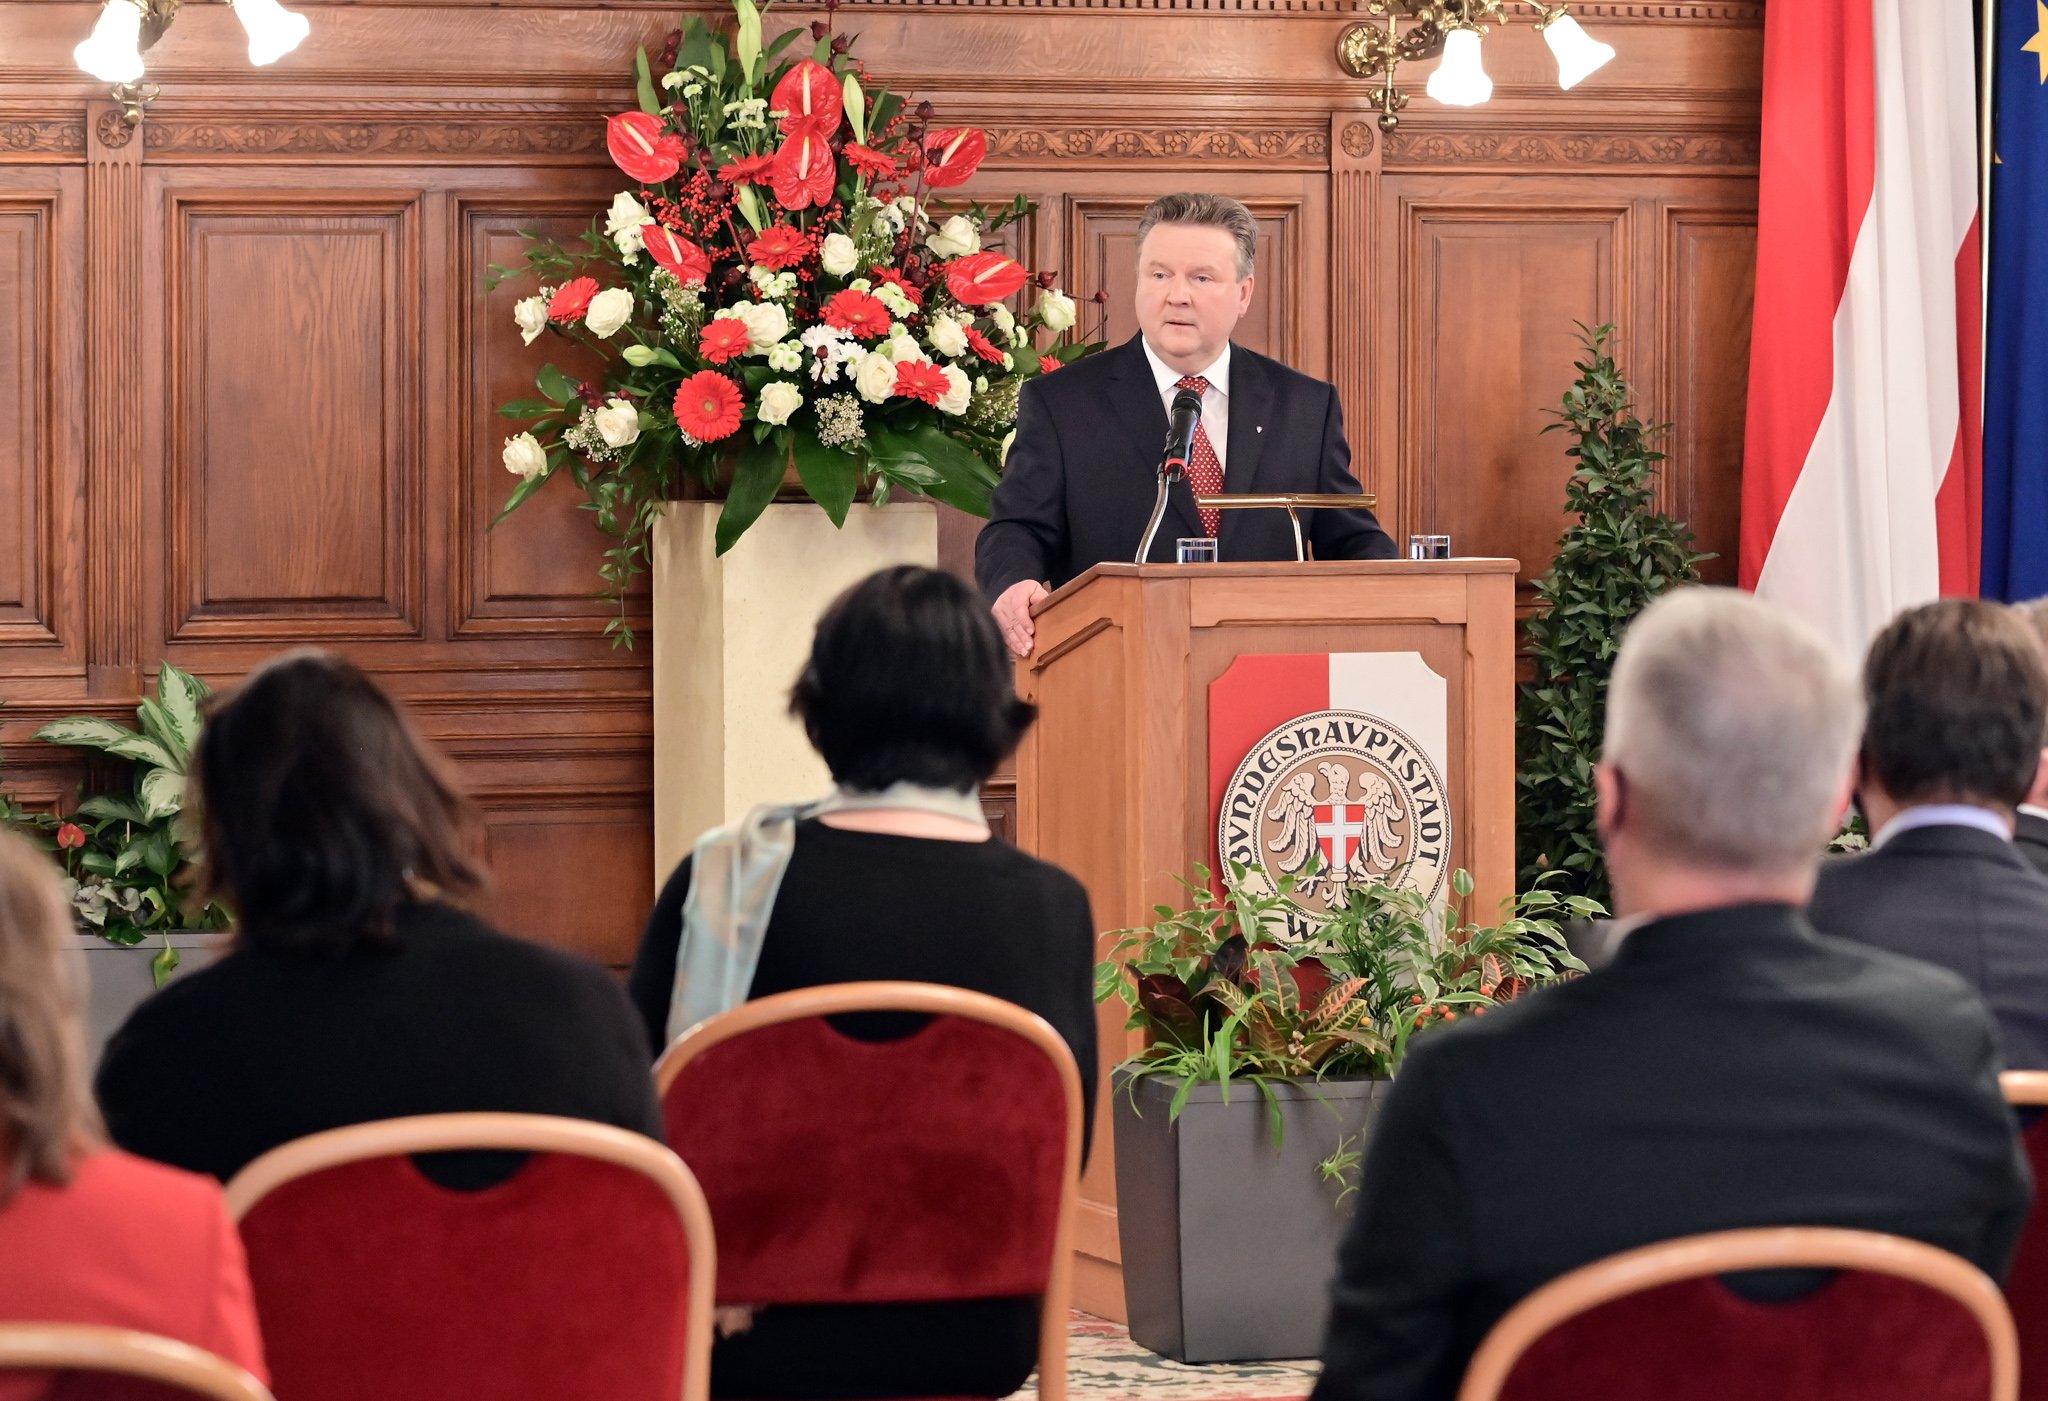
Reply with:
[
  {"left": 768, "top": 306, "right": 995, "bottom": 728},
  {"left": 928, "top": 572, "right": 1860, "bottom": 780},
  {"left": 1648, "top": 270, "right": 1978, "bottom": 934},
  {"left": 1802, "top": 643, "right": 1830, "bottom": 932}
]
[{"left": 629, "top": 567, "right": 1096, "bottom": 1401}]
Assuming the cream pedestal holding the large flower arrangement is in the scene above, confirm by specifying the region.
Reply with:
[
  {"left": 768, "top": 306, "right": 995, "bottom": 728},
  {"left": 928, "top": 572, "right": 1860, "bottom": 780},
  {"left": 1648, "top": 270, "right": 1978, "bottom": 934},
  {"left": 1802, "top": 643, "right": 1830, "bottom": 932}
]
[{"left": 653, "top": 502, "right": 938, "bottom": 889}]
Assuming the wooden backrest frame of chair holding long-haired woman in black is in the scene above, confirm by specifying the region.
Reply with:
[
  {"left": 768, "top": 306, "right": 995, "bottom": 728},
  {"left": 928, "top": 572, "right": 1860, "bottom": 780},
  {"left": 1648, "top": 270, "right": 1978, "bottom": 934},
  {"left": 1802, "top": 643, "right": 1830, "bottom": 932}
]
[{"left": 227, "top": 1114, "right": 719, "bottom": 1401}]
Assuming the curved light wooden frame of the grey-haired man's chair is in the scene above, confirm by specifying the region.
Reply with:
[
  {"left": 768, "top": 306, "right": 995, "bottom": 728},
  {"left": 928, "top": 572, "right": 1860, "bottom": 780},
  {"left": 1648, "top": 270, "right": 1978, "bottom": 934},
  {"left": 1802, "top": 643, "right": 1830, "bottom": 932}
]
[{"left": 1458, "top": 1227, "right": 2019, "bottom": 1401}]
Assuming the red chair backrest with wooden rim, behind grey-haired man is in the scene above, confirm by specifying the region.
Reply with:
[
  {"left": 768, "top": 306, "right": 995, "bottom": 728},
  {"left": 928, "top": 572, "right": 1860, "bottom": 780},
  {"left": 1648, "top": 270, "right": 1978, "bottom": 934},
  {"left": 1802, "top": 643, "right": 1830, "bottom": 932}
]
[{"left": 1458, "top": 1227, "right": 2019, "bottom": 1401}]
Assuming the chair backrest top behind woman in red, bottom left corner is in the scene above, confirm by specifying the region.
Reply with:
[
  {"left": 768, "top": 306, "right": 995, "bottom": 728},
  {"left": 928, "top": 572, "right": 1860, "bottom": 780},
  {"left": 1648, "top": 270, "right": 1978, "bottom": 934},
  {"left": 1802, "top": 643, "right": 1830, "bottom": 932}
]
[{"left": 0, "top": 1323, "right": 272, "bottom": 1401}]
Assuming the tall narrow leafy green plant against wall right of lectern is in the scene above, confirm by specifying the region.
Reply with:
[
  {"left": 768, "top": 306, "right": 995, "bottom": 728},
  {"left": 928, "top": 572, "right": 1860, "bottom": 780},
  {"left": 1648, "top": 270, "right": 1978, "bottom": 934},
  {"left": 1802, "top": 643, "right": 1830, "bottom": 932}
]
[{"left": 1516, "top": 324, "right": 1712, "bottom": 901}]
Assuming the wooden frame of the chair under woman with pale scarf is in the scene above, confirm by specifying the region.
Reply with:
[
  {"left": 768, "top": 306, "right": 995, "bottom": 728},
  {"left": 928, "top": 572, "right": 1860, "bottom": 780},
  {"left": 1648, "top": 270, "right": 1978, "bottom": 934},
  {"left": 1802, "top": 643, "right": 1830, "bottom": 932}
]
[{"left": 653, "top": 981, "right": 1081, "bottom": 1401}]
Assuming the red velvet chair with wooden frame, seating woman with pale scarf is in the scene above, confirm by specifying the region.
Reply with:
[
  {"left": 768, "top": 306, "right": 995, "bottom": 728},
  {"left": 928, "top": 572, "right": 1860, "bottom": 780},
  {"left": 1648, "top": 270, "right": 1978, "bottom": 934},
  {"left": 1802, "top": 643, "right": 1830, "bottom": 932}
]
[{"left": 655, "top": 983, "right": 1081, "bottom": 1401}]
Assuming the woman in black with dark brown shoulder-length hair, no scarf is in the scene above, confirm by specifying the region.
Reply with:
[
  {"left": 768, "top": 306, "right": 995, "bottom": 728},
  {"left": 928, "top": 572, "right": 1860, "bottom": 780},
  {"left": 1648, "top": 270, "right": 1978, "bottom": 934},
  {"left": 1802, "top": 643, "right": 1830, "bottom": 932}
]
[{"left": 98, "top": 651, "right": 662, "bottom": 1186}]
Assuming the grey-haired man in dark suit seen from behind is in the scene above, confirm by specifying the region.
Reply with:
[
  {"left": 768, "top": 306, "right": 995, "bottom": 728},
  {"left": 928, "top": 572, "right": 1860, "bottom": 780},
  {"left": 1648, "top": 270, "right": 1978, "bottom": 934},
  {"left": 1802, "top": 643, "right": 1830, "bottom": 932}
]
[{"left": 1315, "top": 588, "right": 2030, "bottom": 1401}]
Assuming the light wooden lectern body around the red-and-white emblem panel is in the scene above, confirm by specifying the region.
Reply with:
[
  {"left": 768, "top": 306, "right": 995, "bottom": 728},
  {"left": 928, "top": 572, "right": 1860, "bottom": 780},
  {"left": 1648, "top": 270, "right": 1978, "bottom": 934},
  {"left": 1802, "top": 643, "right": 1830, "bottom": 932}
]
[{"left": 1018, "top": 559, "right": 1518, "bottom": 1321}]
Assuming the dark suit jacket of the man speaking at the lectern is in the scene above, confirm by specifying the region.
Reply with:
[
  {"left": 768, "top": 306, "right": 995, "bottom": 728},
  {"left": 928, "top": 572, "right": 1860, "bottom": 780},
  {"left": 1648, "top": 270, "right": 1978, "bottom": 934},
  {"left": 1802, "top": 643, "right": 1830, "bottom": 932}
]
[{"left": 975, "top": 336, "right": 1395, "bottom": 602}]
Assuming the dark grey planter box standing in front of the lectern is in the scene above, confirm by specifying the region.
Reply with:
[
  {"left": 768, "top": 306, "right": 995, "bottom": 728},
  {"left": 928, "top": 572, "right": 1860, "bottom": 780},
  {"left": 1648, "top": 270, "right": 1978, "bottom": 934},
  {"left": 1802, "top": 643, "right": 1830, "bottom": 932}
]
[{"left": 1112, "top": 1069, "right": 1389, "bottom": 1362}]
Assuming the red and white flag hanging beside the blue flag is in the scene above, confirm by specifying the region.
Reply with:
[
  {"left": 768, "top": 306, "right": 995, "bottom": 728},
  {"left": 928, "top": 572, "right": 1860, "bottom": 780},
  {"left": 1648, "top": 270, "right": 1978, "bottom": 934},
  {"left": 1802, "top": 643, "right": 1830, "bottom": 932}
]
[{"left": 1741, "top": 0, "right": 1982, "bottom": 657}]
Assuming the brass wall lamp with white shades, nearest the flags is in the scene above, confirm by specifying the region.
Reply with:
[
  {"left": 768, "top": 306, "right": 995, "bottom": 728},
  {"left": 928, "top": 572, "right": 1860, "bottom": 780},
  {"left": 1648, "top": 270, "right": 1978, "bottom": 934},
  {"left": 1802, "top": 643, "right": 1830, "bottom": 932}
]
[{"left": 1337, "top": 0, "right": 1614, "bottom": 131}]
